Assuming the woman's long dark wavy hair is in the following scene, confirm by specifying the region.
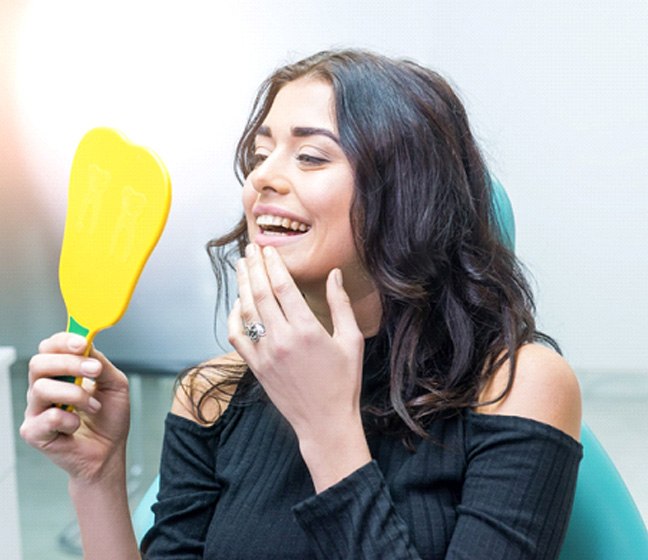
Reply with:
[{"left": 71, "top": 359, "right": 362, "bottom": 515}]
[{"left": 184, "top": 50, "right": 557, "bottom": 435}]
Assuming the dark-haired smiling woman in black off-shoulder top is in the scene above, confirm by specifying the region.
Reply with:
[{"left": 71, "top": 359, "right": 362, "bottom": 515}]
[{"left": 21, "top": 51, "right": 581, "bottom": 559}]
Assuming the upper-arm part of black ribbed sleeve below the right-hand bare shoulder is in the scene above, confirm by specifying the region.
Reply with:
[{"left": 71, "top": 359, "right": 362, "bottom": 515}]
[{"left": 446, "top": 413, "right": 583, "bottom": 560}]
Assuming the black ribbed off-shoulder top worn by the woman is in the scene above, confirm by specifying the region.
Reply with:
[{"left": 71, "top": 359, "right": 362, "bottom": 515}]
[{"left": 142, "top": 344, "right": 582, "bottom": 560}]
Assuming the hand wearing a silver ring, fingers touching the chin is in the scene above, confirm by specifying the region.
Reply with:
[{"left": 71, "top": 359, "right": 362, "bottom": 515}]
[{"left": 228, "top": 245, "right": 371, "bottom": 490}]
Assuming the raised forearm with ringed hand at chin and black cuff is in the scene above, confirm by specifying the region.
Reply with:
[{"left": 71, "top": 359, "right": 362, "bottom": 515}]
[{"left": 228, "top": 246, "right": 419, "bottom": 559}]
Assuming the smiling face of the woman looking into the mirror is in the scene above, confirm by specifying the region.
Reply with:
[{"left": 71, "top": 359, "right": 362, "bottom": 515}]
[{"left": 243, "top": 78, "right": 368, "bottom": 295}]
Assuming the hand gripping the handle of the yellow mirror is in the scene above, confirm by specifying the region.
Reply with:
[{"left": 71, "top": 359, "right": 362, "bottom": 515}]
[{"left": 20, "top": 333, "right": 130, "bottom": 483}]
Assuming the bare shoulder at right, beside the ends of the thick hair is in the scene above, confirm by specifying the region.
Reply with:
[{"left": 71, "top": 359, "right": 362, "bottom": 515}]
[{"left": 476, "top": 344, "right": 581, "bottom": 439}]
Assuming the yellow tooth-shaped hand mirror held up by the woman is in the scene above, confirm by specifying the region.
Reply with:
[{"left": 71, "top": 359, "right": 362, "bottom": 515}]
[{"left": 59, "top": 128, "right": 171, "bottom": 394}]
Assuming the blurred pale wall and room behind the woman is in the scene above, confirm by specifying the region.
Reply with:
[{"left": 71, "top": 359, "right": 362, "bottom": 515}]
[{"left": 0, "top": 0, "right": 648, "bottom": 558}]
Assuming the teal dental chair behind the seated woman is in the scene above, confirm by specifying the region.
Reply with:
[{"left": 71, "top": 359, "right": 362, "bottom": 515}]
[{"left": 132, "top": 180, "right": 648, "bottom": 560}]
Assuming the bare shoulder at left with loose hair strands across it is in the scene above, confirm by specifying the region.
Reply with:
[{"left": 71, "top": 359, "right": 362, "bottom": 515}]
[{"left": 171, "top": 352, "right": 245, "bottom": 425}]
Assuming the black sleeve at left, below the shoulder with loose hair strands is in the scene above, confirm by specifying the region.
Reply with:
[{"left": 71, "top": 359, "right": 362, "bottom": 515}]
[{"left": 141, "top": 413, "right": 224, "bottom": 560}]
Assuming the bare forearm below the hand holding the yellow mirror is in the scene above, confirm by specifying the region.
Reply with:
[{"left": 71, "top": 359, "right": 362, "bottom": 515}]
[{"left": 69, "top": 453, "right": 140, "bottom": 560}]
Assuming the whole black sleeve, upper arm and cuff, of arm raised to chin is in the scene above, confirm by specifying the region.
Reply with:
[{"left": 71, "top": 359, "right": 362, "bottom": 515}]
[{"left": 293, "top": 414, "right": 582, "bottom": 560}]
